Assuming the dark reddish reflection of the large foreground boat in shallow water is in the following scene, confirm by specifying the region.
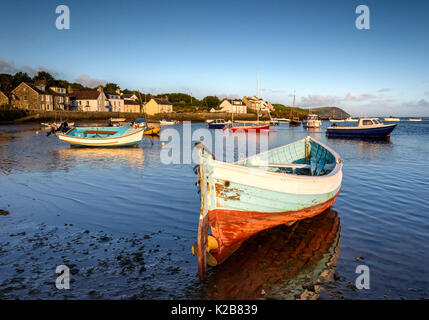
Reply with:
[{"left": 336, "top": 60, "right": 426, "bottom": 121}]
[{"left": 201, "top": 208, "right": 341, "bottom": 299}]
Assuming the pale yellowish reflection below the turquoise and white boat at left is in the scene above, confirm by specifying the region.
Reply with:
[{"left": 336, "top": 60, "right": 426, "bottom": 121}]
[{"left": 54, "top": 148, "right": 144, "bottom": 169}]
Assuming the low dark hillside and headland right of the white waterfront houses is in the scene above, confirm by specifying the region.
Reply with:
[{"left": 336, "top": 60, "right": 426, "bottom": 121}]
[{"left": 273, "top": 104, "right": 350, "bottom": 119}]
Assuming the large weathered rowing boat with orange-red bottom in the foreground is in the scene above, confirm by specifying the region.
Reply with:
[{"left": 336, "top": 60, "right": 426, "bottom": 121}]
[{"left": 193, "top": 137, "right": 342, "bottom": 280}]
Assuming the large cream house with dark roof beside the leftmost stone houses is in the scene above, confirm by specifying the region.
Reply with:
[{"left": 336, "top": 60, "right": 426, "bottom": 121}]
[{"left": 70, "top": 91, "right": 109, "bottom": 111}]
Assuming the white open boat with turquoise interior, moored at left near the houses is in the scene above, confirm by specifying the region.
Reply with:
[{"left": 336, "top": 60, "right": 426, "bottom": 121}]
[{"left": 57, "top": 124, "right": 144, "bottom": 147}]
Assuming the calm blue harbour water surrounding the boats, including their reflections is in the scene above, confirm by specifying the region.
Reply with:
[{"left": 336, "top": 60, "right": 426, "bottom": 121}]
[{"left": 0, "top": 121, "right": 429, "bottom": 299}]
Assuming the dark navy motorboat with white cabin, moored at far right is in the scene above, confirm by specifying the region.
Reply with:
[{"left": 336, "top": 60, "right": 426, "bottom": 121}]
[{"left": 326, "top": 118, "right": 396, "bottom": 138}]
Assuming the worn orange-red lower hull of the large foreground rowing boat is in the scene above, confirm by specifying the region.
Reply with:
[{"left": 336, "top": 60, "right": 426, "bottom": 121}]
[{"left": 203, "top": 191, "right": 340, "bottom": 264}]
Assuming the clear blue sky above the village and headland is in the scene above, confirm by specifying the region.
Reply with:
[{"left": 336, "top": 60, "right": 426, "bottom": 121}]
[{"left": 0, "top": 0, "right": 429, "bottom": 116}]
